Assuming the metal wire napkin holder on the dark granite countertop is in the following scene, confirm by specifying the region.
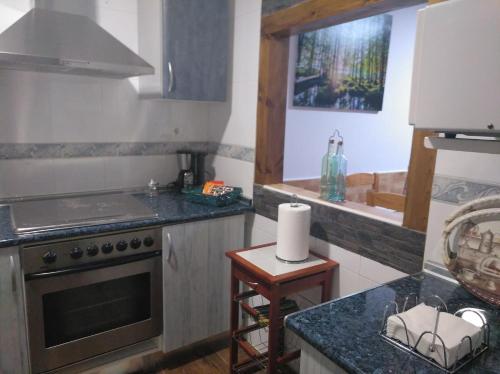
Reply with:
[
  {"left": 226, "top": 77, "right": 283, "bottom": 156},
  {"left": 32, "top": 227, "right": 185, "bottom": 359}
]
[{"left": 380, "top": 294, "right": 490, "bottom": 374}]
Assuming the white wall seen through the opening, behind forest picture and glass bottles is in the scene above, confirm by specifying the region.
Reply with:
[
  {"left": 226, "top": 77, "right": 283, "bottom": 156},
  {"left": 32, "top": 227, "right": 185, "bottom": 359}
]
[{"left": 284, "top": 6, "right": 421, "bottom": 179}]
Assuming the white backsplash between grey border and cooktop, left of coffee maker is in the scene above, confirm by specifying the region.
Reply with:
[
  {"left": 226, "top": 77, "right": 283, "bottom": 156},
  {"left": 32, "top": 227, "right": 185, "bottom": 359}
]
[{"left": 0, "top": 155, "right": 177, "bottom": 197}]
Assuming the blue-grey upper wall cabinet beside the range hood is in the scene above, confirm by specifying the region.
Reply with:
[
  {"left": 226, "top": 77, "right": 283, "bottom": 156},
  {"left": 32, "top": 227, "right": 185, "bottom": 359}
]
[{"left": 139, "top": 0, "right": 231, "bottom": 101}]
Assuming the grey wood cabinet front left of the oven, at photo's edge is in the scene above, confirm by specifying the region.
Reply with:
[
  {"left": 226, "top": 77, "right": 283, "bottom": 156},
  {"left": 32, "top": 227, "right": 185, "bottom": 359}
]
[{"left": 0, "top": 248, "right": 29, "bottom": 373}]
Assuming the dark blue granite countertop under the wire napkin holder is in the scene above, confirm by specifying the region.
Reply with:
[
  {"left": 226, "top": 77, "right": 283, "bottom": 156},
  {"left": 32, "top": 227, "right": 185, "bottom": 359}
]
[{"left": 285, "top": 273, "right": 500, "bottom": 374}]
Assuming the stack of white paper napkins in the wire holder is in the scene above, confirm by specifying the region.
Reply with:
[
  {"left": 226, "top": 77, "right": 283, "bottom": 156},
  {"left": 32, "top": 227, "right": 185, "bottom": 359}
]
[{"left": 386, "top": 303, "right": 483, "bottom": 368}]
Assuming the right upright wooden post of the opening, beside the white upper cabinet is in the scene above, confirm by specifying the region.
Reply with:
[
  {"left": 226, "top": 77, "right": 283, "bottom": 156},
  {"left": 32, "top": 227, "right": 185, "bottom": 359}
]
[{"left": 403, "top": 130, "right": 437, "bottom": 232}]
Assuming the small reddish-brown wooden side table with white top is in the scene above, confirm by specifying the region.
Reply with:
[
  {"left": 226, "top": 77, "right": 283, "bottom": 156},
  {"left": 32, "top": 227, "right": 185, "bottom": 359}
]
[{"left": 226, "top": 243, "right": 338, "bottom": 374}]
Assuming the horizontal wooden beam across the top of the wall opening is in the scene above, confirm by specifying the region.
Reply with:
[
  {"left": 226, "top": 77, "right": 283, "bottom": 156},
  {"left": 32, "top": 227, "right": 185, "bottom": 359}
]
[{"left": 261, "top": 0, "right": 426, "bottom": 36}]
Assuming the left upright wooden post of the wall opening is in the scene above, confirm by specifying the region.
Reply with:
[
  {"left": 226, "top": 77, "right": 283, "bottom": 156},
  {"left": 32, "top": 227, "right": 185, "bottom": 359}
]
[{"left": 255, "top": 35, "right": 289, "bottom": 184}]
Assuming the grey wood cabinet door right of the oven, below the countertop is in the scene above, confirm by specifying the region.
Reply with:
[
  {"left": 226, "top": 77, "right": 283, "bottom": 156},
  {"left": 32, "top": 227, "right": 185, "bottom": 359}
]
[{"left": 163, "top": 215, "right": 245, "bottom": 352}]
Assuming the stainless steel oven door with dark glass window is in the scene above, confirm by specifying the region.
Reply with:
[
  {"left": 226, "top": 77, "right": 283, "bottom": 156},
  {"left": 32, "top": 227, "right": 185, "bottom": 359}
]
[{"left": 26, "top": 253, "right": 162, "bottom": 373}]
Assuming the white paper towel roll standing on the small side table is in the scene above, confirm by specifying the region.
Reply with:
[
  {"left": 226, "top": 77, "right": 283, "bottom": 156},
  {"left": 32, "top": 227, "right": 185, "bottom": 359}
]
[{"left": 276, "top": 203, "right": 311, "bottom": 261}]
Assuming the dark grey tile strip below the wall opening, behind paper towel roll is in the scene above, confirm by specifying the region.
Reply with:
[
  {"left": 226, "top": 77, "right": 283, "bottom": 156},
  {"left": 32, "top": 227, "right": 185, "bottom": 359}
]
[{"left": 254, "top": 185, "right": 425, "bottom": 274}]
